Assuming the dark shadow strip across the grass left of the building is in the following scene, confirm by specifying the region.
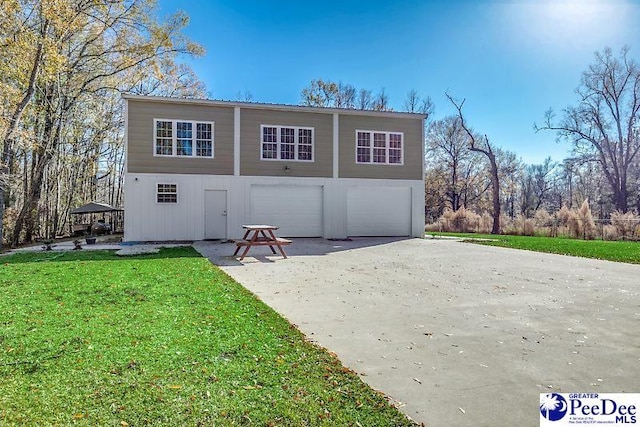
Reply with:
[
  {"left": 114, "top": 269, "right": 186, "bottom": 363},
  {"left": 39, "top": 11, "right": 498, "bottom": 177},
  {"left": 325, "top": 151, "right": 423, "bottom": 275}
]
[{"left": 0, "top": 246, "right": 201, "bottom": 267}]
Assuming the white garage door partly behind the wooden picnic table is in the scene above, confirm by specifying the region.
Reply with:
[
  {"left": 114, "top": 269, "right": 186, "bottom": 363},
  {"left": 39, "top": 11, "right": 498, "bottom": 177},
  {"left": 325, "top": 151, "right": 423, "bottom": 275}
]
[{"left": 251, "top": 185, "right": 322, "bottom": 237}]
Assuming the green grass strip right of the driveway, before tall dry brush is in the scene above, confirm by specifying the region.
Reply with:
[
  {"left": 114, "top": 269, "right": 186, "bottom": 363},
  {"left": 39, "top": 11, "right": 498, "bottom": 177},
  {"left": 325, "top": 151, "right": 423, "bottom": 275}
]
[{"left": 426, "top": 233, "right": 640, "bottom": 264}]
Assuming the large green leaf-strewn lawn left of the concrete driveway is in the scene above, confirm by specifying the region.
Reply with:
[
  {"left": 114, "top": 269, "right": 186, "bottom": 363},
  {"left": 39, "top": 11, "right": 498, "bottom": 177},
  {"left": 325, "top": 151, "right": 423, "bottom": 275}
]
[{"left": 0, "top": 248, "right": 413, "bottom": 426}]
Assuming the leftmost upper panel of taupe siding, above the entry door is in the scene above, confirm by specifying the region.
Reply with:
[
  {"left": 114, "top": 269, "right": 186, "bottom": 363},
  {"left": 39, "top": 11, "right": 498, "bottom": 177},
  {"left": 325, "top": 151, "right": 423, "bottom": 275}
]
[{"left": 127, "top": 99, "right": 233, "bottom": 175}]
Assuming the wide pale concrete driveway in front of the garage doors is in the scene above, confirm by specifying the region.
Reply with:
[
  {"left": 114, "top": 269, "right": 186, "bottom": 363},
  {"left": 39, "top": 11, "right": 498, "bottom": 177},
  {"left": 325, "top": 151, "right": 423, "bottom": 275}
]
[{"left": 194, "top": 238, "right": 640, "bottom": 426}]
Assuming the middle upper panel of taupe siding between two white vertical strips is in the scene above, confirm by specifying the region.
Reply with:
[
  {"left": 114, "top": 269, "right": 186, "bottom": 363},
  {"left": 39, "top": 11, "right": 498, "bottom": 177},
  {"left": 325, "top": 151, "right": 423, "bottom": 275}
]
[{"left": 240, "top": 108, "right": 333, "bottom": 177}]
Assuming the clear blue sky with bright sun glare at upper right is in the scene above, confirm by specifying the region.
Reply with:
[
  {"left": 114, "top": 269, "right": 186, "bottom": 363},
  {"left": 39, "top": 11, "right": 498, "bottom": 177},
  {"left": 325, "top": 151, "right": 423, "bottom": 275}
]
[{"left": 158, "top": 0, "right": 640, "bottom": 163}]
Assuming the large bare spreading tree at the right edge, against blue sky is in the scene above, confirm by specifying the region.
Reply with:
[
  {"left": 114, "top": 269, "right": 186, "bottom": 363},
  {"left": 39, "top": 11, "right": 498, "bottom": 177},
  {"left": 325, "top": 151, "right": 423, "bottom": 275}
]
[{"left": 536, "top": 47, "right": 640, "bottom": 212}]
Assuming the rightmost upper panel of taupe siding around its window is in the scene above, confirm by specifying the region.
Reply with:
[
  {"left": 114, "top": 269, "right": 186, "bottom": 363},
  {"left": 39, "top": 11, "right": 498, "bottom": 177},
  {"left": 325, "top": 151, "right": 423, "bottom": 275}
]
[{"left": 339, "top": 114, "right": 424, "bottom": 180}]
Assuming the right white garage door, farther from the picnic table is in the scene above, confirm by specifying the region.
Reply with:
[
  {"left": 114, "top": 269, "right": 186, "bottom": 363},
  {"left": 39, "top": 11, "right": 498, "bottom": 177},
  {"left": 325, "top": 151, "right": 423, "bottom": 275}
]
[{"left": 347, "top": 187, "right": 411, "bottom": 236}]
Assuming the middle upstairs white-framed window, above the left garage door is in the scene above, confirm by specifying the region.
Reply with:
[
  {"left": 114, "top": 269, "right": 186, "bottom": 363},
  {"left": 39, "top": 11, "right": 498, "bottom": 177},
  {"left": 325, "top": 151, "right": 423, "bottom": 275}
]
[{"left": 260, "top": 125, "right": 313, "bottom": 162}]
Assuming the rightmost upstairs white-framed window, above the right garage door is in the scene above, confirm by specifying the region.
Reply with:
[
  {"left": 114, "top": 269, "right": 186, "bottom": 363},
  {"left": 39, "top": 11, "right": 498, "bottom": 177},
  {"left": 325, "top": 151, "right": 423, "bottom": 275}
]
[{"left": 356, "top": 130, "right": 404, "bottom": 165}]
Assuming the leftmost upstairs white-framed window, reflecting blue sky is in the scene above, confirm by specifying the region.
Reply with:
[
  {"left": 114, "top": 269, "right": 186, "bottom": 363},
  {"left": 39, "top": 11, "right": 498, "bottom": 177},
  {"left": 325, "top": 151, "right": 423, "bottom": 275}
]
[{"left": 153, "top": 119, "right": 214, "bottom": 158}]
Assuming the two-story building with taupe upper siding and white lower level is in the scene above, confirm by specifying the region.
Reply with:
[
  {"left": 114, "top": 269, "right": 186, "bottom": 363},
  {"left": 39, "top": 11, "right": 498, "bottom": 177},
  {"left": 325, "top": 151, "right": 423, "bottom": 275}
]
[{"left": 124, "top": 95, "right": 425, "bottom": 241}]
